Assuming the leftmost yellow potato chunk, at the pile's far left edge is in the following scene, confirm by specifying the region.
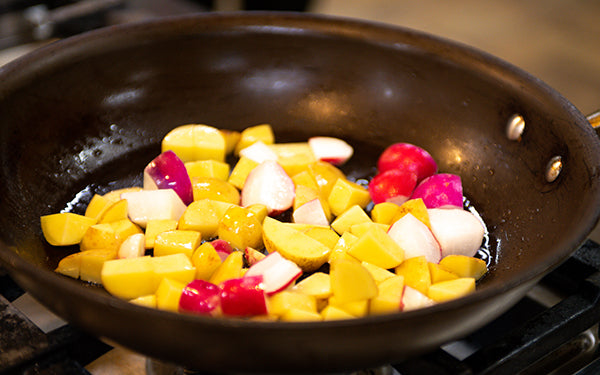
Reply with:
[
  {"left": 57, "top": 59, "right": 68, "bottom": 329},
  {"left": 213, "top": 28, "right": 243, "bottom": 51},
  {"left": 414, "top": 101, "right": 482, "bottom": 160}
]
[{"left": 40, "top": 212, "right": 96, "bottom": 246}]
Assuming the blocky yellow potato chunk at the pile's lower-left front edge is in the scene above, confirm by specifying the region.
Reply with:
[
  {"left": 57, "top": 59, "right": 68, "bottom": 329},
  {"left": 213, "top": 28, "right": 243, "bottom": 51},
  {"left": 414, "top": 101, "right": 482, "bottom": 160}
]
[{"left": 101, "top": 256, "right": 158, "bottom": 300}]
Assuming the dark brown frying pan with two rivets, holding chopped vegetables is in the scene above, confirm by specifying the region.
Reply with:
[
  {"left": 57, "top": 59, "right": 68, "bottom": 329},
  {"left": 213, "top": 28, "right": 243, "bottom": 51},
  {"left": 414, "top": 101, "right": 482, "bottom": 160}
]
[{"left": 0, "top": 13, "right": 600, "bottom": 372}]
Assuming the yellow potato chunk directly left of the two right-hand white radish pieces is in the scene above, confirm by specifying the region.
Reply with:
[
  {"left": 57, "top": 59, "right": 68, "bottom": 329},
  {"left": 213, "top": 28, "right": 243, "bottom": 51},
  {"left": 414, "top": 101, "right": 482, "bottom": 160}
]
[{"left": 348, "top": 227, "right": 404, "bottom": 269}]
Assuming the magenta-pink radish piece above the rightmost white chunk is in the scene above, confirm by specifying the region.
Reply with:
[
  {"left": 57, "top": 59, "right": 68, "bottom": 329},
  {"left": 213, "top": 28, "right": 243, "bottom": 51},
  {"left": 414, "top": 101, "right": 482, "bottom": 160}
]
[{"left": 411, "top": 173, "right": 463, "bottom": 208}]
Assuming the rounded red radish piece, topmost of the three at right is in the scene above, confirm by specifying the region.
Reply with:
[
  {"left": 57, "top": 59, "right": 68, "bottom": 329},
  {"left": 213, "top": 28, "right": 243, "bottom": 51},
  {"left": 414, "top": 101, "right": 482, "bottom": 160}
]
[{"left": 377, "top": 143, "right": 437, "bottom": 182}]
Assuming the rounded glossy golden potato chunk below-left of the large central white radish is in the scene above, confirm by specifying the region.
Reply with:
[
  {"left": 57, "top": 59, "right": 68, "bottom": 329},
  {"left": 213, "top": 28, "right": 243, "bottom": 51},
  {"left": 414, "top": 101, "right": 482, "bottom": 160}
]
[{"left": 217, "top": 206, "right": 263, "bottom": 250}]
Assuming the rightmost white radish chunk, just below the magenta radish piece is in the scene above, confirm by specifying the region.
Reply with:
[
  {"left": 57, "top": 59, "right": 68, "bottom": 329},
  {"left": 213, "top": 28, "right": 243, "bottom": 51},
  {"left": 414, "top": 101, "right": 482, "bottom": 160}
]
[{"left": 427, "top": 208, "right": 485, "bottom": 258}]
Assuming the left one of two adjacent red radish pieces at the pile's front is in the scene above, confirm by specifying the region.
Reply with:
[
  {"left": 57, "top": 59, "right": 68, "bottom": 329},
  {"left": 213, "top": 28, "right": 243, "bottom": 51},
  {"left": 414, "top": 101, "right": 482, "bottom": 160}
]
[{"left": 179, "top": 279, "right": 221, "bottom": 315}]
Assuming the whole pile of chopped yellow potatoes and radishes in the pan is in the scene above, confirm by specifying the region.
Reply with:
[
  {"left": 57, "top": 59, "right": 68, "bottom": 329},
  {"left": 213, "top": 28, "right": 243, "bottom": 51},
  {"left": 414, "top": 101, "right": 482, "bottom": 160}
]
[{"left": 41, "top": 124, "right": 487, "bottom": 321}]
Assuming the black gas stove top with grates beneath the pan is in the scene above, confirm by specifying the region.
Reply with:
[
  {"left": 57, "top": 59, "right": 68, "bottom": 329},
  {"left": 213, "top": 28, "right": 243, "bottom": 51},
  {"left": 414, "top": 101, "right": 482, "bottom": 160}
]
[{"left": 0, "top": 240, "right": 600, "bottom": 375}]
